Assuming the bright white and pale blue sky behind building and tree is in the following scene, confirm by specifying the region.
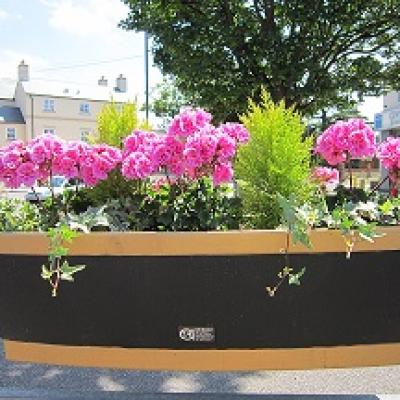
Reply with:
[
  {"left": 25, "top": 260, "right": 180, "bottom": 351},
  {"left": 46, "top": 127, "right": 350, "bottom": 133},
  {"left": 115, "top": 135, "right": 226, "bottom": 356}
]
[{"left": 0, "top": 0, "right": 383, "bottom": 120}]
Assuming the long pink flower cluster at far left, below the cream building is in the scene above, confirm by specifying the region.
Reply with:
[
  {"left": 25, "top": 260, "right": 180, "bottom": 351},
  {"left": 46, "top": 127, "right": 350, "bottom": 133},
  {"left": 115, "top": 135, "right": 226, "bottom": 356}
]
[{"left": 0, "top": 135, "right": 122, "bottom": 188}]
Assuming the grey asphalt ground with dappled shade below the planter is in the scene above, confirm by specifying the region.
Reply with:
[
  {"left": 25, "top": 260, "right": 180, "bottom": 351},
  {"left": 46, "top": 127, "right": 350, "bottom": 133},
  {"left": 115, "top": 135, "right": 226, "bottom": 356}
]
[{"left": 0, "top": 339, "right": 400, "bottom": 399}]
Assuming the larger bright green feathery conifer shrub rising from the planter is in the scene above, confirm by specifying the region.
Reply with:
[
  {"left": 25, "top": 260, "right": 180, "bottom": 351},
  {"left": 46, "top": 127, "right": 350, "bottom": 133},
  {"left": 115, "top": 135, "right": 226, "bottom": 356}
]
[{"left": 236, "top": 89, "right": 313, "bottom": 228}]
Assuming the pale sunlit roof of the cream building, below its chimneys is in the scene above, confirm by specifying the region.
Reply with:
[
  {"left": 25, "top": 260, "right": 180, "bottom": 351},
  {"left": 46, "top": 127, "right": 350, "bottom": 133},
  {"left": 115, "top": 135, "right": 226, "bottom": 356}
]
[{"left": 21, "top": 79, "right": 129, "bottom": 103}]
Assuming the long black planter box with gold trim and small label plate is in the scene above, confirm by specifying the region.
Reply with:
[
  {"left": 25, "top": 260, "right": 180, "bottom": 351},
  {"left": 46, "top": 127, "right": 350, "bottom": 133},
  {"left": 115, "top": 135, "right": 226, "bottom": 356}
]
[{"left": 0, "top": 228, "right": 400, "bottom": 369}]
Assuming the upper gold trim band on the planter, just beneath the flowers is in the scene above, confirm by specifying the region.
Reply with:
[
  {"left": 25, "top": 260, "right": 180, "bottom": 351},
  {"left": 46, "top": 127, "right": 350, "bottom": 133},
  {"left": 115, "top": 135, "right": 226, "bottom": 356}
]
[{"left": 0, "top": 226, "right": 400, "bottom": 256}]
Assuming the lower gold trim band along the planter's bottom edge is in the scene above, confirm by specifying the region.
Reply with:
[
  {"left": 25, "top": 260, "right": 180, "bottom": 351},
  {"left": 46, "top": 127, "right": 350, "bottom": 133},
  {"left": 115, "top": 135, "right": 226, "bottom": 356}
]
[{"left": 4, "top": 340, "right": 400, "bottom": 371}]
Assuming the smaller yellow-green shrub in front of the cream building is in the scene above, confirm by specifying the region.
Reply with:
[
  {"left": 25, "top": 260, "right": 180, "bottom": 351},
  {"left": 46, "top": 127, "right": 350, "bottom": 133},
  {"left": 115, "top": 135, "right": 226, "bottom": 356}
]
[{"left": 94, "top": 102, "right": 139, "bottom": 148}]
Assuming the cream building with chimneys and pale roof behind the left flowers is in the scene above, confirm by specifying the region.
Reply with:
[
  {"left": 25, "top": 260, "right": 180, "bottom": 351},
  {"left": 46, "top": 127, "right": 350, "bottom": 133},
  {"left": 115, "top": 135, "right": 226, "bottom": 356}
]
[{"left": 0, "top": 61, "right": 129, "bottom": 146}]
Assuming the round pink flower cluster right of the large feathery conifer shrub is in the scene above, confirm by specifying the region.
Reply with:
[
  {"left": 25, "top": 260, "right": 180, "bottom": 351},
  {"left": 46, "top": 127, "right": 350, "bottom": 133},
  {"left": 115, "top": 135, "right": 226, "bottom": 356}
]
[{"left": 315, "top": 119, "right": 376, "bottom": 165}]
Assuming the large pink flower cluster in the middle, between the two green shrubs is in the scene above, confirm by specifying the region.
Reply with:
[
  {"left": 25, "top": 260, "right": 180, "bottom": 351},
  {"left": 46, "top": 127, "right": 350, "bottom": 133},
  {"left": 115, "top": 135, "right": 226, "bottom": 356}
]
[{"left": 122, "top": 108, "right": 249, "bottom": 185}]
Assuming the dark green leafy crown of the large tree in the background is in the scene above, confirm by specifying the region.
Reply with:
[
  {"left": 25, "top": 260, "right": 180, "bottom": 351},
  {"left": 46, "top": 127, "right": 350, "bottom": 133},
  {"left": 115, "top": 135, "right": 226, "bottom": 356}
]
[{"left": 121, "top": 0, "right": 400, "bottom": 120}]
